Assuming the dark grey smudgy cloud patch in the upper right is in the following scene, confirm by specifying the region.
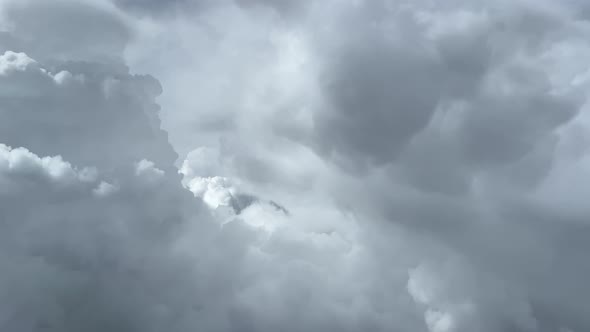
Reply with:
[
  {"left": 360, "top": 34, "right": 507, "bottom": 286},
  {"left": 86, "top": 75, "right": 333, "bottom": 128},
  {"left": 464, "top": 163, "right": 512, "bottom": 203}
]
[{"left": 314, "top": 2, "right": 580, "bottom": 171}]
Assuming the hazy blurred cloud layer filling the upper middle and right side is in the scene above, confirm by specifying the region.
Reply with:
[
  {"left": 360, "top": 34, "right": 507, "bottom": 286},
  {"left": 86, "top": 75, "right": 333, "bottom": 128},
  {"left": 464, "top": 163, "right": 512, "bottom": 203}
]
[{"left": 129, "top": 1, "right": 590, "bottom": 331}]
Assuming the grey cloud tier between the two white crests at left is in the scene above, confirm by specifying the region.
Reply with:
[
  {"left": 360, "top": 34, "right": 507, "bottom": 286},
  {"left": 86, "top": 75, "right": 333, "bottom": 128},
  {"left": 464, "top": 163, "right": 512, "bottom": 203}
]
[{"left": 0, "top": 51, "right": 176, "bottom": 176}]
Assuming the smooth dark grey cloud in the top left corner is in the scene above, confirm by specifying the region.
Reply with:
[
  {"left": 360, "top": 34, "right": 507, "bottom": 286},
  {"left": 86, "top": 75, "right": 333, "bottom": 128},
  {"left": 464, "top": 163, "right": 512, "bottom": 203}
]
[{"left": 0, "top": 0, "right": 132, "bottom": 61}]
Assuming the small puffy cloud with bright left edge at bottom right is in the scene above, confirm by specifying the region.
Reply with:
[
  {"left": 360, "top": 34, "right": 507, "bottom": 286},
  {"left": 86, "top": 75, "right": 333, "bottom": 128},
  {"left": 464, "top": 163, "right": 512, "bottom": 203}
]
[{"left": 408, "top": 259, "right": 539, "bottom": 332}]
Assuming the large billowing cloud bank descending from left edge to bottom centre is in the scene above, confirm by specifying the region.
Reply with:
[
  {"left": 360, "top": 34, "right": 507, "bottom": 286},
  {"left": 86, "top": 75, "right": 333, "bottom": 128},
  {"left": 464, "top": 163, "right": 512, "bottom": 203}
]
[{"left": 0, "top": 2, "right": 426, "bottom": 332}]
